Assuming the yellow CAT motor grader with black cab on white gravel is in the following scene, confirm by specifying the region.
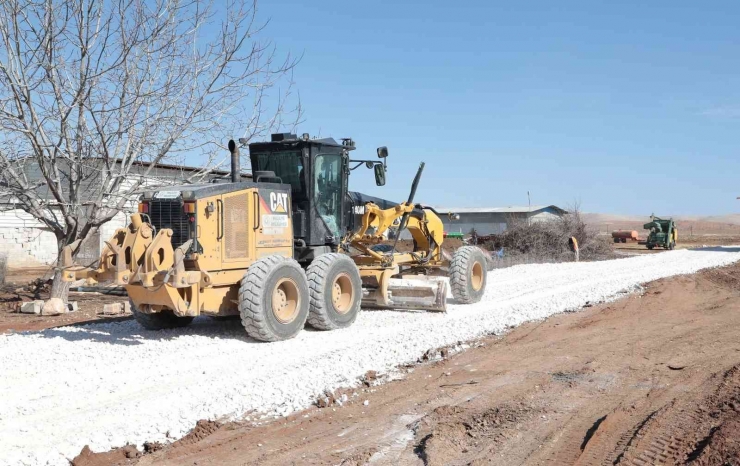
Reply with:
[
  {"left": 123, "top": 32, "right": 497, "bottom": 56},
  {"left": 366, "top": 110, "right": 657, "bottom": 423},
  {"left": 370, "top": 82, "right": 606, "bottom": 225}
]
[{"left": 62, "top": 134, "right": 486, "bottom": 341}]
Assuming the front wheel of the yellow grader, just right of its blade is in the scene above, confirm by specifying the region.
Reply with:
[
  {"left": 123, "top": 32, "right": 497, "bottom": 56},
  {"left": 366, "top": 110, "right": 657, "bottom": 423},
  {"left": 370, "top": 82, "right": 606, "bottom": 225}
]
[{"left": 450, "top": 246, "right": 488, "bottom": 304}]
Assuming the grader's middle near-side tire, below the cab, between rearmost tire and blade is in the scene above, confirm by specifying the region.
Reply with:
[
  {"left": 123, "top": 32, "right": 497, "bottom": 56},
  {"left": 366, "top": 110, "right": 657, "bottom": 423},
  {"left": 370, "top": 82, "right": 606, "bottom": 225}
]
[{"left": 306, "top": 253, "right": 362, "bottom": 330}]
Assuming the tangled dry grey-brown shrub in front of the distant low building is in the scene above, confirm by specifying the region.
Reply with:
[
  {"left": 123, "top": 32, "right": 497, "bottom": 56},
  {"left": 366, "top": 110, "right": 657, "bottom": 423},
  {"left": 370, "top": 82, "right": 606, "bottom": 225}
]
[{"left": 485, "top": 206, "right": 615, "bottom": 262}]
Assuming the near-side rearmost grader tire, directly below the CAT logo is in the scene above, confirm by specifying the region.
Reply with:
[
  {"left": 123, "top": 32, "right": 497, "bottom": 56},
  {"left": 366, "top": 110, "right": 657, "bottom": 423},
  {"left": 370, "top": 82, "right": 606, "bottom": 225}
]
[{"left": 239, "top": 255, "right": 309, "bottom": 341}]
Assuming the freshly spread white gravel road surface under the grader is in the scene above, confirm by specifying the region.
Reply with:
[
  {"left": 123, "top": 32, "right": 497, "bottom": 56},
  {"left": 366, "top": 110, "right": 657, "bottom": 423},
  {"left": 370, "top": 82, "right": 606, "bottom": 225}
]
[{"left": 0, "top": 248, "right": 740, "bottom": 465}]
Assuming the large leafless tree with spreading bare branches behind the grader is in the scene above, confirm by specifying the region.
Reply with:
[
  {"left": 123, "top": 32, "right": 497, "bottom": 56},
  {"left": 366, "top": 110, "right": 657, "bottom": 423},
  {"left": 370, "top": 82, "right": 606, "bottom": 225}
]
[{"left": 0, "top": 0, "right": 300, "bottom": 300}]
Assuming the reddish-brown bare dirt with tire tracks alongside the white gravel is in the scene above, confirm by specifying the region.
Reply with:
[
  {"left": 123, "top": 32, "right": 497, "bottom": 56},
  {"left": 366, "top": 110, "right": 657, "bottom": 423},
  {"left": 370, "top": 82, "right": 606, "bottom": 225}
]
[{"left": 82, "top": 264, "right": 740, "bottom": 466}]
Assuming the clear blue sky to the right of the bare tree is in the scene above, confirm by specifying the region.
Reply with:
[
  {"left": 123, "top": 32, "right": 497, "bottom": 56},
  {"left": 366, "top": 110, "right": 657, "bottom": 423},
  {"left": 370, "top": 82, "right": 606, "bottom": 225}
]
[{"left": 250, "top": 0, "right": 740, "bottom": 215}]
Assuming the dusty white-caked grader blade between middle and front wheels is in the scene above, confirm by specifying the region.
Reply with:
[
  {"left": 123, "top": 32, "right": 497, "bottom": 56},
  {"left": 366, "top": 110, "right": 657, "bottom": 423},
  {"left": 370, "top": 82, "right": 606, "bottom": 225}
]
[{"left": 362, "top": 276, "right": 447, "bottom": 312}]
